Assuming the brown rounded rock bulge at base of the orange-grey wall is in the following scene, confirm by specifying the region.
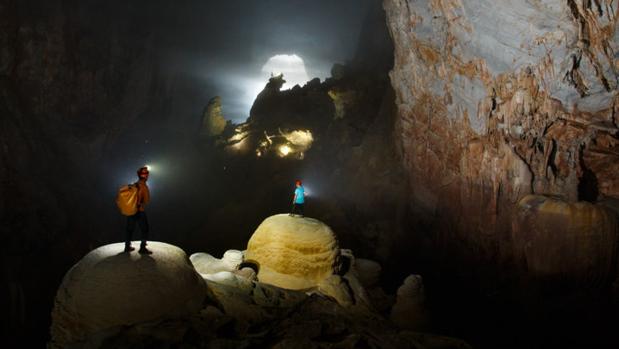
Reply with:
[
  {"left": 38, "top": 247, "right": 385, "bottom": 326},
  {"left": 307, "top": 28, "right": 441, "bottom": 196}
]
[{"left": 514, "top": 195, "right": 619, "bottom": 287}]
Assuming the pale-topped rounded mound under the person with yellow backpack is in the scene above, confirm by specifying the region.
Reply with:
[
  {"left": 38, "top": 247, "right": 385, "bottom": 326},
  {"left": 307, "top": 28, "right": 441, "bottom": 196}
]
[{"left": 51, "top": 242, "right": 206, "bottom": 347}]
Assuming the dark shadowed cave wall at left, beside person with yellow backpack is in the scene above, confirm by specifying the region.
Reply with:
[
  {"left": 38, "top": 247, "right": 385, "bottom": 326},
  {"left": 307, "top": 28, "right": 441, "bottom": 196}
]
[{"left": 0, "top": 0, "right": 170, "bottom": 346}]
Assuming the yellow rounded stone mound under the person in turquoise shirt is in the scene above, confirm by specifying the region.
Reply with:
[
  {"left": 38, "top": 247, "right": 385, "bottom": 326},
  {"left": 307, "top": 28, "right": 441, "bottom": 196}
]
[{"left": 245, "top": 214, "right": 340, "bottom": 290}]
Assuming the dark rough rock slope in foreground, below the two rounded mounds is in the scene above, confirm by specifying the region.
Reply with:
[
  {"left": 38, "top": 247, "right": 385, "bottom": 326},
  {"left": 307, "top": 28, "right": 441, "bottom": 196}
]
[{"left": 80, "top": 282, "right": 470, "bottom": 349}]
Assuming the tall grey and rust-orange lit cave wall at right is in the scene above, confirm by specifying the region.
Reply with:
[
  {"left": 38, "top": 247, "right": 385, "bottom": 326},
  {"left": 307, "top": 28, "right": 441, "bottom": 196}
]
[{"left": 383, "top": 0, "right": 619, "bottom": 286}]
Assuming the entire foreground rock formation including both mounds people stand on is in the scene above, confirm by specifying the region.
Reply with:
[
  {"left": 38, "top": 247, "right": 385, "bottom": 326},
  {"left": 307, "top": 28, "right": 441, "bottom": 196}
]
[{"left": 51, "top": 223, "right": 470, "bottom": 349}]
